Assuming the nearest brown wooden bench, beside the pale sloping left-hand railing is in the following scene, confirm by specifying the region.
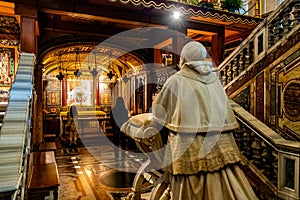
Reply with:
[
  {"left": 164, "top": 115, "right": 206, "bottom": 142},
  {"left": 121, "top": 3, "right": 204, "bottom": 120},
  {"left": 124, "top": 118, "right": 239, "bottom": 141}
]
[{"left": 28, "top": 151, "right": 59, "bottom": 200}]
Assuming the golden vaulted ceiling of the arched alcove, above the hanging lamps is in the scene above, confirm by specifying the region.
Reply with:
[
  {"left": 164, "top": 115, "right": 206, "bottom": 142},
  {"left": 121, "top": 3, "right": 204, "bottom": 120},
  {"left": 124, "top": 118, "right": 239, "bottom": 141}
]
[{"left": 41, "top": 43, "right": 143, "bottom": 77}]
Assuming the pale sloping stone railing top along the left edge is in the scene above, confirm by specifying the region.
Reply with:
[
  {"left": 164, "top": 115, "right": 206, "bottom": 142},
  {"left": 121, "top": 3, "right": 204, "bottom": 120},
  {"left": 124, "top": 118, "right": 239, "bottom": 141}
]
[{"left": 0, "top": 53, "right": 34, "bottom": 199}]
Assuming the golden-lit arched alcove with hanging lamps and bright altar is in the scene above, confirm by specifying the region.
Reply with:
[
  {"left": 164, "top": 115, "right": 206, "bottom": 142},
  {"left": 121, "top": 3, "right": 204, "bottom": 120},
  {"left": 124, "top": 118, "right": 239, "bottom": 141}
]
[{"left": 39, "top": 42, "right": 146, "bottom": 138}]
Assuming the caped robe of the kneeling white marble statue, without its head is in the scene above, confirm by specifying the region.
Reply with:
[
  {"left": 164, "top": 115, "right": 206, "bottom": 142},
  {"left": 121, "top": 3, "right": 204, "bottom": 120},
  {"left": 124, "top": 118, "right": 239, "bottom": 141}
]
[{"left": 123, "top": 67, "right": 257, "bottom": 200}]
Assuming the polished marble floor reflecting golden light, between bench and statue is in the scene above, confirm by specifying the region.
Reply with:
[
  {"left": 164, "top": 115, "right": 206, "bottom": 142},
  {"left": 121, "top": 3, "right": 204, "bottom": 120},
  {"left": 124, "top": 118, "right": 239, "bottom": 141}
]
[{"left": 56, "top": 135, "right": 147, "bottom": 200}]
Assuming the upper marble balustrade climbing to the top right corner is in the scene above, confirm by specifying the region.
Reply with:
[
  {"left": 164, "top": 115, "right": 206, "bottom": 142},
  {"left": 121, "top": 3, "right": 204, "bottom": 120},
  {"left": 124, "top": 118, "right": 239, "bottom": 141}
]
[{"left": 218, "top": 0, "right": 300, "bottom": 89}]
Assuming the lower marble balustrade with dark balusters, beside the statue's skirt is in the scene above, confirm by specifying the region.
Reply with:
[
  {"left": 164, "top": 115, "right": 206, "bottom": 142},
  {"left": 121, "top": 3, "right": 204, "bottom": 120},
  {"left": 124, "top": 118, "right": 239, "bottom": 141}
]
[{"left": 231, "top": 101, "right": 300, "bottom": 200}]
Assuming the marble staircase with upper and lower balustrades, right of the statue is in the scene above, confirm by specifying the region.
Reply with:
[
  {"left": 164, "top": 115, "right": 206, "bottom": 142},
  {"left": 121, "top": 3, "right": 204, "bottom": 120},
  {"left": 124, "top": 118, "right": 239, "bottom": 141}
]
[{"left": 218, "top": 0, "right": 300, "bottom": 200}]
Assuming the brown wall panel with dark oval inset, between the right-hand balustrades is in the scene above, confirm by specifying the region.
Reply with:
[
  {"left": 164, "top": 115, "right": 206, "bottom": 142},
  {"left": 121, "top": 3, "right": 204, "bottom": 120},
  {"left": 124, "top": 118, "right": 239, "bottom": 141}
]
[{"left": 270, "top": 49, "right": 300, "bottom": 140}]
